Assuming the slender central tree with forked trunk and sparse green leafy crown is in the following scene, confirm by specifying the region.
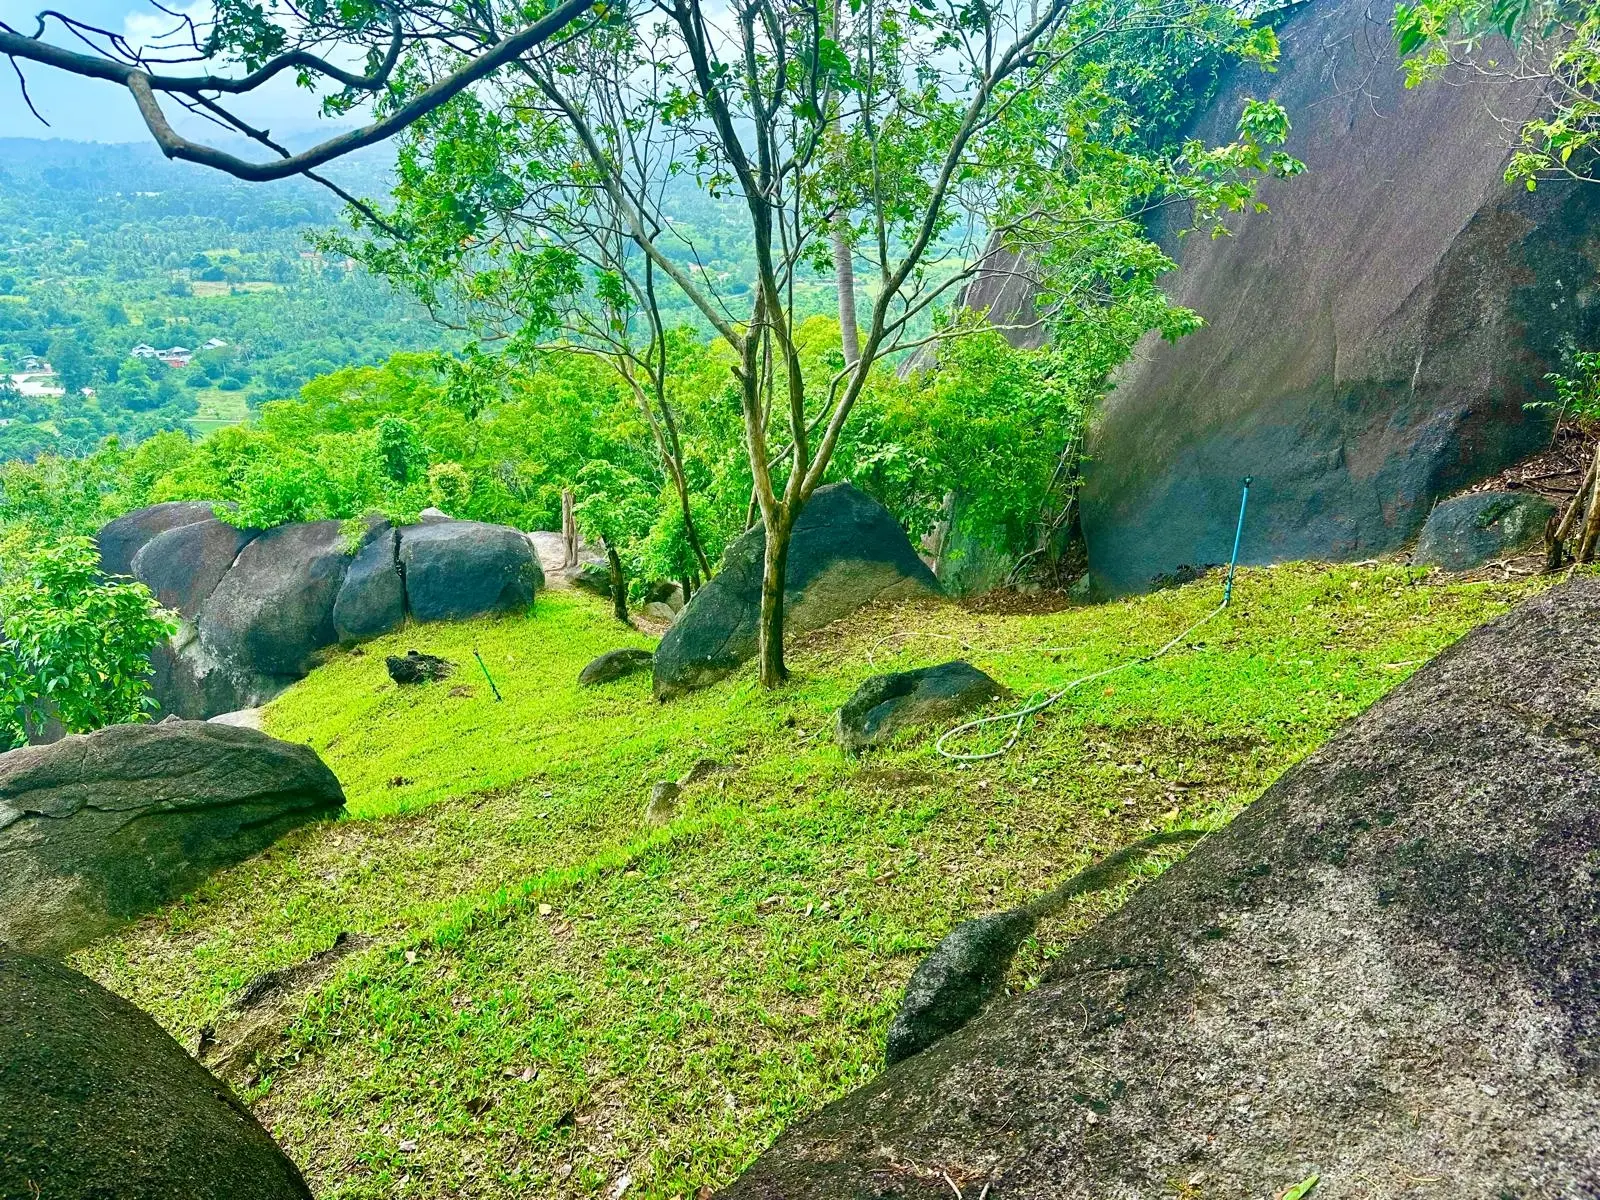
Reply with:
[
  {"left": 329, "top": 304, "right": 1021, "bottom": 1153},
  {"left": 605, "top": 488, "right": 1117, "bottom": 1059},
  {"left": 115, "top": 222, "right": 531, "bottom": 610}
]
[{"left": 344, "top": 0, "right": 1293, "bottom": 686}]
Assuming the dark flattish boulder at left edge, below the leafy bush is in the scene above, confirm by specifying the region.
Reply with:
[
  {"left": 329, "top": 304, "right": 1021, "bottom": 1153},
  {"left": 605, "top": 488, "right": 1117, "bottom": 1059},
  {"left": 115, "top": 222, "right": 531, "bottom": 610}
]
[{"left": 0, "top": 718, "right": 344, "bottom": 954}]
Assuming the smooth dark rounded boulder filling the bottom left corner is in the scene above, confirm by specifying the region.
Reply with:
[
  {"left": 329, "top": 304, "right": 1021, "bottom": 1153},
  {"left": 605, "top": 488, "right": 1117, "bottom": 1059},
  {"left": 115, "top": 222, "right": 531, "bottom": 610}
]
[{"left": 0, "top": 946, "right": 310, "bottom": 1200}]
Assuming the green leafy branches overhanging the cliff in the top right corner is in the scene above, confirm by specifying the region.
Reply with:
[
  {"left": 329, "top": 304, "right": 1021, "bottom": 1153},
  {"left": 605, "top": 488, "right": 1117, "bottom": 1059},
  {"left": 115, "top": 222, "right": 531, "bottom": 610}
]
[{"left": 1394, "top": 0, "right": 1600, "bottom": 192}]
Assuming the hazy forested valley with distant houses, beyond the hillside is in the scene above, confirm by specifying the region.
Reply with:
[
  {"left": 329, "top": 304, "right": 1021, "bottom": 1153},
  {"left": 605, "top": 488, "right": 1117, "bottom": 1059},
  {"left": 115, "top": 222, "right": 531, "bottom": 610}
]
[{"left": 0, "top": 139, "right": 451, "bottom": 461}]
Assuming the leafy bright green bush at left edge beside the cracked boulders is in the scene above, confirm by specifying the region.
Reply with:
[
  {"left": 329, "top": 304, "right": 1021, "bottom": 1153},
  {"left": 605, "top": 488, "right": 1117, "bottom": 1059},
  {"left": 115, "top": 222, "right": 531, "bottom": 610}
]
[{"left": 0, "top": 536, "right": 176, "bottom": 746}]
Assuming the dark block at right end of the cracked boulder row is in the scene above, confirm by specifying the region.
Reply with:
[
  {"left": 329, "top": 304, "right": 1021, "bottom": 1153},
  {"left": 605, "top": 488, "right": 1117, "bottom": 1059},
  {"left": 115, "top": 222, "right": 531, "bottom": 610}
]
[{"left": 400, "top": 522, "right": 544, "bottom": 621}]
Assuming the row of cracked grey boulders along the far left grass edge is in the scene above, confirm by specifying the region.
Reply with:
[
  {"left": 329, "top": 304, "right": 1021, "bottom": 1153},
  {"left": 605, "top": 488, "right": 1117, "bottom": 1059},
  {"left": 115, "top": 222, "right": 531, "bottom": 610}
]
[{"left": 99, "top": 502, "right": 544, "bottom": 718}]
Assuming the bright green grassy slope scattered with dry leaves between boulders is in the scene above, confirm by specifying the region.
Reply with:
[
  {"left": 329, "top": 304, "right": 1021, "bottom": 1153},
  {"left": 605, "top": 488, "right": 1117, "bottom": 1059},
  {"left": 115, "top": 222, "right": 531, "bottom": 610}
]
[{"left": 78, "top": 566, "right": 1528, "bottom": 1198}]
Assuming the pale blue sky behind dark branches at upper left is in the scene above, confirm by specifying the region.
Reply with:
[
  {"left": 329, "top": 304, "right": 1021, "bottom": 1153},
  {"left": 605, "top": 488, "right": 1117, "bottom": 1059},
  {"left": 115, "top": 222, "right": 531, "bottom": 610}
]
[{"left": 0, "top": 0, "right": 349, "bottom": 142}]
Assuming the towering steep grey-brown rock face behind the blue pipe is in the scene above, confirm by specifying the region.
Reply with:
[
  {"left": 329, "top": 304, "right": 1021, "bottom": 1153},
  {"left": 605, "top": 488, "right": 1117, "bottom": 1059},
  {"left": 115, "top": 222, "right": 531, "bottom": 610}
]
[{"left": 1082, "top": 0, "right": 1600, "bottom": 594}]
